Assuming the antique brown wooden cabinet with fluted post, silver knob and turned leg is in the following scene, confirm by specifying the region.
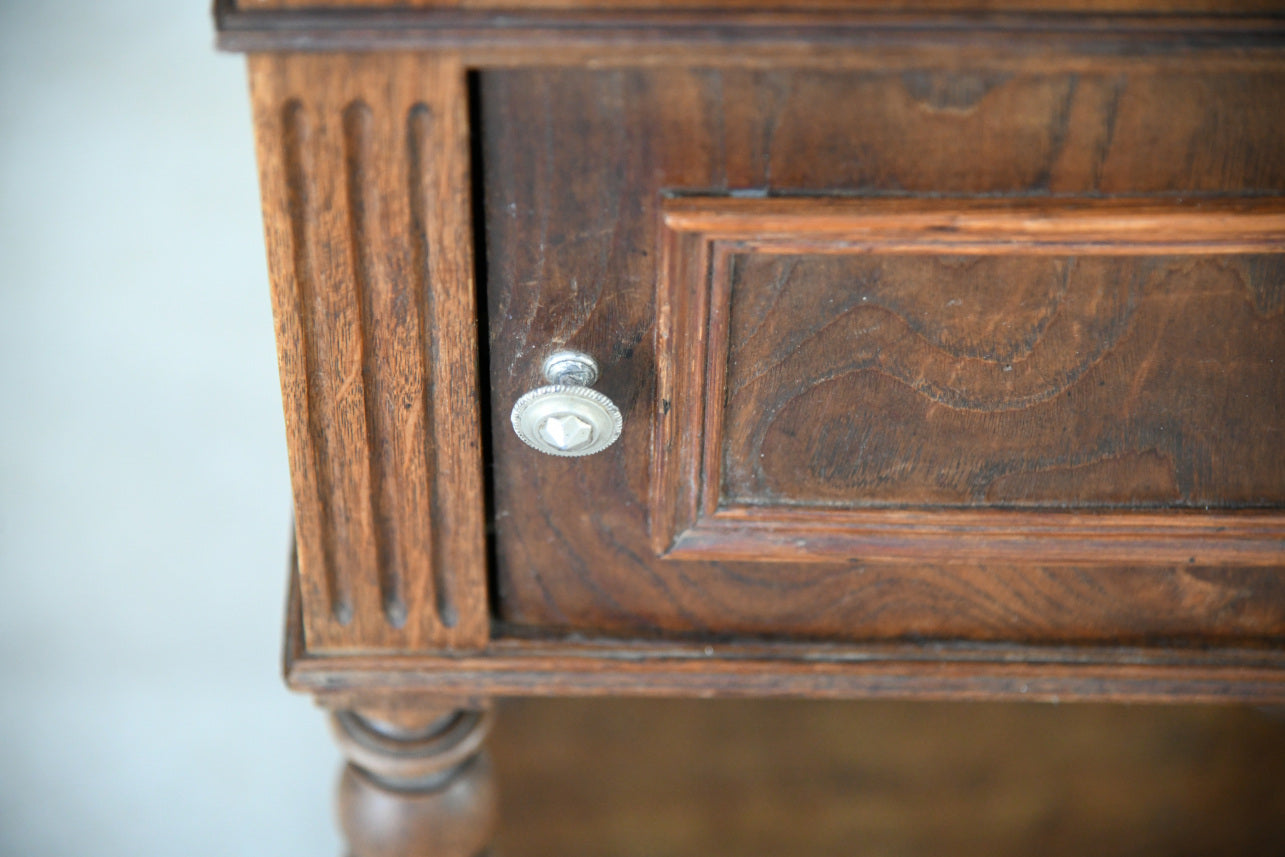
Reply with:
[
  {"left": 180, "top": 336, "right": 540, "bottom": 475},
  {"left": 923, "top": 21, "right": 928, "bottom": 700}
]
[{"left": 216, "top": 0, "right": 1285, "bottom": 856}]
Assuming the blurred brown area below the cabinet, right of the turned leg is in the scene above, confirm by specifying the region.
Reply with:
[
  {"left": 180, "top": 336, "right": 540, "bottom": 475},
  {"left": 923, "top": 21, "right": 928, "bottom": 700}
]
[{"left": 491, "top": 700, "right": 1285, "bottom": 857}]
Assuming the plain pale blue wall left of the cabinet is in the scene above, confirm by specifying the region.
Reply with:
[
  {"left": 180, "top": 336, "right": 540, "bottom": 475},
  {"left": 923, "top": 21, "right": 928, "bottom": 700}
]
[{"left": 0, "top": 0, "right": 339, "bottom": 857}]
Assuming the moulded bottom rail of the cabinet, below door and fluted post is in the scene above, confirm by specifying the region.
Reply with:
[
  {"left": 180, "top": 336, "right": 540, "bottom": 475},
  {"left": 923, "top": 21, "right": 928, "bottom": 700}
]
[{"left": 283, "top": 562, "right": 1285, "bottom": 704}]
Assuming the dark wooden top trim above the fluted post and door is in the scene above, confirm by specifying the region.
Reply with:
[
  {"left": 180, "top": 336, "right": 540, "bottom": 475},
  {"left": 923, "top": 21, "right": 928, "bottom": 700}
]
[{"left": 215, "top": 0, "right": 1285, "bottom": 72}]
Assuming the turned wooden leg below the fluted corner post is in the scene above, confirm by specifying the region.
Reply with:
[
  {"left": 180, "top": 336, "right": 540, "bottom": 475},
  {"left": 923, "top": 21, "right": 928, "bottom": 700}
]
[{"left": 332, "top": 709, "right": 496, "bottom": 857}]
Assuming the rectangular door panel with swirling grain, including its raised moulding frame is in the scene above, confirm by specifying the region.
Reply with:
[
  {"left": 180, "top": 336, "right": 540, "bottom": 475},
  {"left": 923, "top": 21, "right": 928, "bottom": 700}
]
[{"left": 651, "top": 198, "right": 1285, "bottom": 565}]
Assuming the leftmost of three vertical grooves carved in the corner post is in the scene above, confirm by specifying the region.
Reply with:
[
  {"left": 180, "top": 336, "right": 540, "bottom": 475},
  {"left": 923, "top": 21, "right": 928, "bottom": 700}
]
[{"left": 281, "top": 99, "right": 352, "bottom": 624}]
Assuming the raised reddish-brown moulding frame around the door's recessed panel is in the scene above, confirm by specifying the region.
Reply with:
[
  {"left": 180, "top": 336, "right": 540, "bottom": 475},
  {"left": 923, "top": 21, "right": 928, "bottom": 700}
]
[{"left": 650, "top": 197, "right": 1285, "bottom": 565}]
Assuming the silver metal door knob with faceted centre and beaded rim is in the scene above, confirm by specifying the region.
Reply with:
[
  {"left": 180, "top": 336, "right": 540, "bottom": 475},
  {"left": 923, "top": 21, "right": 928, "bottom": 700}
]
[{"left": 510, "top": 351, "right": 623, "bottom": 456}]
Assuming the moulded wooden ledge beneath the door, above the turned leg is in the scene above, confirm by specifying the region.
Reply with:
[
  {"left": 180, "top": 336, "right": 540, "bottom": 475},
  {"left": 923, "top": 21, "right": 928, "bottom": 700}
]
[{"left": 288, "top": 644, "right": 1285, "bottom": 705}]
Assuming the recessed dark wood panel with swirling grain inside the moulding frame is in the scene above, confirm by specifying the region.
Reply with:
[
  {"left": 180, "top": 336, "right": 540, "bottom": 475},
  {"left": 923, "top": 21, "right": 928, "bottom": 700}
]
[{"left": 718, "top": 244, "right": 1285, "bottom": 508}]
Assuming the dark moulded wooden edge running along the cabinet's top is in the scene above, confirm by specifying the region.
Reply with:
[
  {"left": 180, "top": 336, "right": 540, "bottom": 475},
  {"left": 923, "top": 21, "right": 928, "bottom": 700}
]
[{"left": 213, "top": 0, "right": 1285, "bottom": 67}]
